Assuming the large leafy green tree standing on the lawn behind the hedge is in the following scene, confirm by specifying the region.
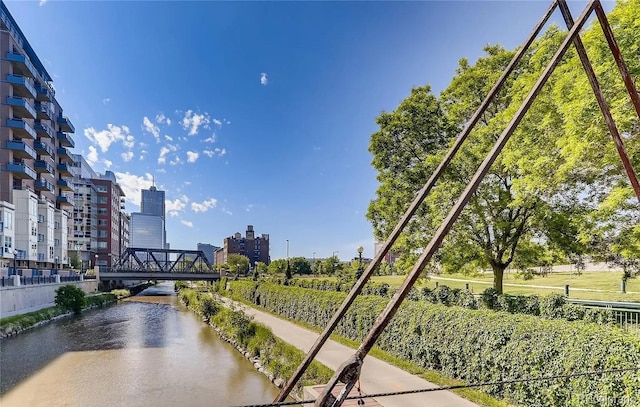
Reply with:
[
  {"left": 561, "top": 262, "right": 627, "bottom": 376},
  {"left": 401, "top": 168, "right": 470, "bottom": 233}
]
[{"left": 367, "top": 1, "right": 640, "bottom": 292}]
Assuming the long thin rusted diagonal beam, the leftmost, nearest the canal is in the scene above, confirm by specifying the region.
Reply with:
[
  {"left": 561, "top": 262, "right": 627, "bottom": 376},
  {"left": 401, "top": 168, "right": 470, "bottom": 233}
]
[{"left": 275, "top": 1, "right": 557, "bottom": 402}]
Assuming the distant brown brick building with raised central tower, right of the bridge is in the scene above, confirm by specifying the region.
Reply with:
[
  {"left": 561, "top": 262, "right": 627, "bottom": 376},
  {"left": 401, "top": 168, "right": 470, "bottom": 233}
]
[{"left": 215, "top": 225, "right": 271, "bottom": 267}]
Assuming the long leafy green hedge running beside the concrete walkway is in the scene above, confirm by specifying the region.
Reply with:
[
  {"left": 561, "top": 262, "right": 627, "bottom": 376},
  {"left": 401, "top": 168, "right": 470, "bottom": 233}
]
[{"left": 231, "top": 281, "right": 640, "bottom": 407}]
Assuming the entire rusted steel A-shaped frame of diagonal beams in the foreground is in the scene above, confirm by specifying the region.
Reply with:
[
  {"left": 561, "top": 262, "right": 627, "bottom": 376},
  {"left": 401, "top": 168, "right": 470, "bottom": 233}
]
[{"left": 275, "top": 0, "right": 640, "bottom": 407}]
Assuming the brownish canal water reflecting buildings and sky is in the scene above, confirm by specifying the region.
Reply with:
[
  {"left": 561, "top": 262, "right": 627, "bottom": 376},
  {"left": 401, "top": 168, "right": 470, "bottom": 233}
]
[{"left": 0, "top": 283, "right": 277, "bottom": 407}]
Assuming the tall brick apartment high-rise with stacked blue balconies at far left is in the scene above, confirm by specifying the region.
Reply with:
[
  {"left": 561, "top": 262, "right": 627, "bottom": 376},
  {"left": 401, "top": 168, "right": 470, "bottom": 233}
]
[{"left": 0, "top": 2, "right": 75, "bottom": 275}]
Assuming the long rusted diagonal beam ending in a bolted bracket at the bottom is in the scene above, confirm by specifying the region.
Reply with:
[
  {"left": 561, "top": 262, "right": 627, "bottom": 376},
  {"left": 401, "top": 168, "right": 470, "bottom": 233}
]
[{"left": 315, "top": 0, "right": 597, "bottom": 407}]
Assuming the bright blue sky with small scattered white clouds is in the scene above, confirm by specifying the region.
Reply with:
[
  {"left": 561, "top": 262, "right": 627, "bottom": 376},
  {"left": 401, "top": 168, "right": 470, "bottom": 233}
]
[{"left": 7, "top": 0, "right": 613, "bottom": 259}]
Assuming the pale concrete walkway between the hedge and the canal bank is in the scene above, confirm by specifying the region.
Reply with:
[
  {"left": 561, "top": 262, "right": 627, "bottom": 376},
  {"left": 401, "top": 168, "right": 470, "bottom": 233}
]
[{"left": 228, "top": 304, "right": 477, "bottom": 407}]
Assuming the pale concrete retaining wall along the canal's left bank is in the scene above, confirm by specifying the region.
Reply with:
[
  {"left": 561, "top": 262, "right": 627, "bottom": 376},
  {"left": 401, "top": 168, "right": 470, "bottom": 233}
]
[{"left": 0, "top": 280, "right": 98, "bottom": 318}]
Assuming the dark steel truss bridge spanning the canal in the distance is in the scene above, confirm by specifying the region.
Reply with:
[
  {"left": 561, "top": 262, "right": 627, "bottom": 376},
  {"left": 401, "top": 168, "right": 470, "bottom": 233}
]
[{"left": 113, "top": 247, "right": 214, "bottom": 273}]
